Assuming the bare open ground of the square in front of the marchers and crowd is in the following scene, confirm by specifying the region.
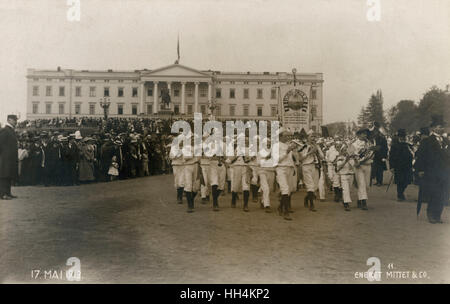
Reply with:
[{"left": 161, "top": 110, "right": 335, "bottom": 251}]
[{"left": 0, "top": 175, "right": 450, "bottom": 283}]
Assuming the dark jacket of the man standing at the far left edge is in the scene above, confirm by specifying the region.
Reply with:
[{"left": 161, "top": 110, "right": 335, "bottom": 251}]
[{"left": 0, "top": 126, "right": 19, "bottom": 179}]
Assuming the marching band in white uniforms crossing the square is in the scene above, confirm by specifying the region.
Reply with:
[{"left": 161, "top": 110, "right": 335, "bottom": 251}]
[{"left": 171, "top": 119, "right": 450, "bottom": 220}]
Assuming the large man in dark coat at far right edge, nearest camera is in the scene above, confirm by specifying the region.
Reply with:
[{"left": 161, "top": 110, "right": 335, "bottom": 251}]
[{"left": 414, "top": 115, "right": 450, "bottom": 224}]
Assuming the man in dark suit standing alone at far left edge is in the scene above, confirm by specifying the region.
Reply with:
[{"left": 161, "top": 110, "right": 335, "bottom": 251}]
[{"left": 0, "top": 115, "right": 19, "bottom": 200}]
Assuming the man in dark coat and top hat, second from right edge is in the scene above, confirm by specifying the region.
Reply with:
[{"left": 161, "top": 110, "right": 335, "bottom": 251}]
[{"left": 389, "top": 129, "right": 414, "bottom": 202}]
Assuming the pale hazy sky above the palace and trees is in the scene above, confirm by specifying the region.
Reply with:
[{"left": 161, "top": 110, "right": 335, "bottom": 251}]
[{"left": 0, "top": 0, "right": 450, "bottom": 123}]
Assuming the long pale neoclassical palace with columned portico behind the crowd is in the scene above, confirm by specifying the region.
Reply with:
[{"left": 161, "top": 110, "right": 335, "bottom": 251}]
[{"left": 27, "top": 64, "right": 323, "bottom": 130}]
